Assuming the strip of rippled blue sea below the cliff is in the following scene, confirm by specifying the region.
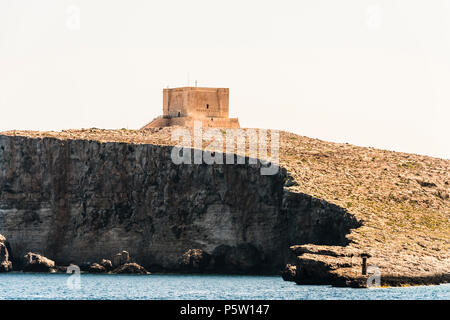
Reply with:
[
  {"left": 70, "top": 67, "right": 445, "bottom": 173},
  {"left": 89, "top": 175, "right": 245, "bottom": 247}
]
[{"left": 0, "top": 273, "right": 450, "bottom": 300}]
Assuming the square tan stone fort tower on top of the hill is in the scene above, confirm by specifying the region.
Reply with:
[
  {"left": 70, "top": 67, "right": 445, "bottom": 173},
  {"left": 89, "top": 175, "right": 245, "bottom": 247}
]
[{"left": 142, "top": 87, "right": 240, "bottom": 129}]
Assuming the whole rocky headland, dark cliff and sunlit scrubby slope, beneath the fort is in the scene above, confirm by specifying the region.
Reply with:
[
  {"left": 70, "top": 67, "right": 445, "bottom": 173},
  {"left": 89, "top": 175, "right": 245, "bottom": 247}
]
[{"left": 0, "top": 128, "right": 450, "bottom": 286}]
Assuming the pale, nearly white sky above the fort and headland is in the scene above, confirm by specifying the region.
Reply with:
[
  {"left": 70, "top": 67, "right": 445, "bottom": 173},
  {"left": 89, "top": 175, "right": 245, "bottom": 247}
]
[{"left": 0, "top": 0, "right": 450, "bottom": 159}]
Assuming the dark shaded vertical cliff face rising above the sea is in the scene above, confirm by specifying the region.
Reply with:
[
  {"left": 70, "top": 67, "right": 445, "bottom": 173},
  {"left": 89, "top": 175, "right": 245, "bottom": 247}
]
[{"left": 0, "top": 135, "right": 358, "bottom": 273}]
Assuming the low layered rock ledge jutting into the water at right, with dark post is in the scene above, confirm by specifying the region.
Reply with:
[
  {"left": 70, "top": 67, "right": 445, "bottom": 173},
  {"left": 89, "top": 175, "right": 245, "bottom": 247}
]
[{"left": 281, "top": 245, "right": 450, "bottom": 288}]
